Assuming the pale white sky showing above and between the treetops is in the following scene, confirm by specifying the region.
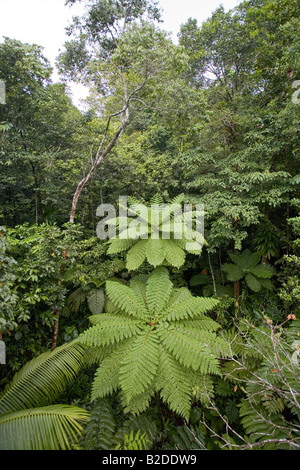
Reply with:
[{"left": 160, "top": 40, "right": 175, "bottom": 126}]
[{"left": 0, "top": 0, "right": 240, "bottom": 105}]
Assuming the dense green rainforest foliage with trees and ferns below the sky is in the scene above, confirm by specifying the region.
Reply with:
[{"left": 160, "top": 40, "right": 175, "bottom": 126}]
[{"left": 0, "top": 0, "right": 300, "bottom": 450}]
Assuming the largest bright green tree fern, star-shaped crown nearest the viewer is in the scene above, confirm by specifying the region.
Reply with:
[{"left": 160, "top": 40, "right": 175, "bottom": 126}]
[{"left": 78, "top": 266, "right": 221, "bottom": 419}]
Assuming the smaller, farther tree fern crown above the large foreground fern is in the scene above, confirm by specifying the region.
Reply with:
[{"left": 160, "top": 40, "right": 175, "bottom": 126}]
[{"left": 108, "top": 195, "right": 205, "bottom": 270}]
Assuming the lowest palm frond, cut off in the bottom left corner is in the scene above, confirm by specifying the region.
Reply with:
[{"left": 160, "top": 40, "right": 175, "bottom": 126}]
[{"left": 0, "top": 405, "right": 89, "bottom": 450}]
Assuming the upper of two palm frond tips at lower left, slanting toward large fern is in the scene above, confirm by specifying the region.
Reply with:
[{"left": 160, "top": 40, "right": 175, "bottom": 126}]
[{"left": 0, "top": 342, "right": 86, "bottom": 414}]
